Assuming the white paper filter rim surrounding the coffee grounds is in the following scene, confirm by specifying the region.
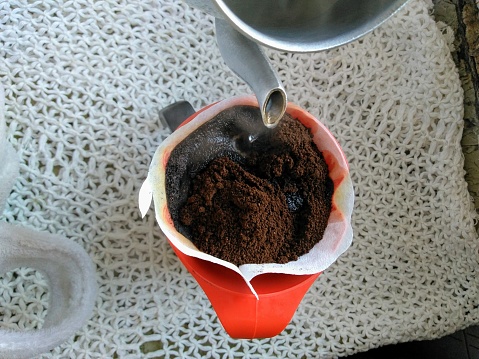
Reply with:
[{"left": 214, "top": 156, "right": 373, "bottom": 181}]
[{"left": 139, "top": 96, "right": 354, "bottom": 294}]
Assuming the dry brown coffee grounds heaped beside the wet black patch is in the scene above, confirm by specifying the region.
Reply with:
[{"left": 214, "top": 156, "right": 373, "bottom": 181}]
[{"left": 178, "top": 111, "right": 333, "bottom": 265}]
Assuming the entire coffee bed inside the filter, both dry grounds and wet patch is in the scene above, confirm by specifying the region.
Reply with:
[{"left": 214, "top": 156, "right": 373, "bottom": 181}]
[{"left": 166, "top": 106, "right": 333, "bottom": 265}]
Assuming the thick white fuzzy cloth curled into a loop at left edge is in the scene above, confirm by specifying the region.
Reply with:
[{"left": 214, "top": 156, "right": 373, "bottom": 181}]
[{"left": 0, "top": 86, "right": 97, "bottom": 359}]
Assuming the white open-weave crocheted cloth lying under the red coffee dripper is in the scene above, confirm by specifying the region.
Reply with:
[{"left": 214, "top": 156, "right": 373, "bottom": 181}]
[{"left": 0, "top": 0, "right": 479, "bottom": 358}]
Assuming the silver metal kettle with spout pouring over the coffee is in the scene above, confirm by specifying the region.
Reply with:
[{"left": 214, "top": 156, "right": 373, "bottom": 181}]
[{"left": 185, "top": 0, "right": 407, "bottom": 127}]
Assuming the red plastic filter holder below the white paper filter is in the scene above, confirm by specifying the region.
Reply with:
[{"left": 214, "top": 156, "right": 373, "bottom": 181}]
[{"left": 170, "top": 242, "right": 320, "bottom": 339}]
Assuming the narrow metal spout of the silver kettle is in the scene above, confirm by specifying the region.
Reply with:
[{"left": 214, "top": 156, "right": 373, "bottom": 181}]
[{"left": 215, "top": 18, "right": 287, "bottom": 128}]
